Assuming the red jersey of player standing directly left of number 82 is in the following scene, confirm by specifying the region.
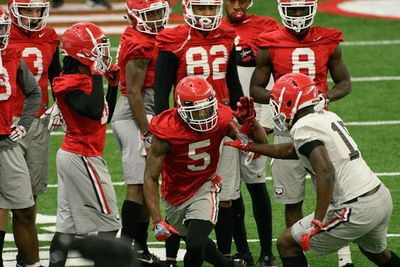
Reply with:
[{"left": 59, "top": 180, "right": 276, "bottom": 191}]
[{"left": 117, "top": 26, "right": 158, "bottom": 96}]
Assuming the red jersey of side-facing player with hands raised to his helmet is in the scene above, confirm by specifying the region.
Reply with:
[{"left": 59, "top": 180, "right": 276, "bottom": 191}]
[{"left": 53, "top": 74, "right": 108, "bottom": 157}]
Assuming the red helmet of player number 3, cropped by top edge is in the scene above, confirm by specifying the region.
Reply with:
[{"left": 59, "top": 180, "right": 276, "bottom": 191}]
[{"left": 8, "top": 0, "right": 50, "bottom": 31}]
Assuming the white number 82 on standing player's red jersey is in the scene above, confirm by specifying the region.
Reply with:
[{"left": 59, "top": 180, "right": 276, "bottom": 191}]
[{"left": 186, "top": 45, "right": 228, "bottom": 80}]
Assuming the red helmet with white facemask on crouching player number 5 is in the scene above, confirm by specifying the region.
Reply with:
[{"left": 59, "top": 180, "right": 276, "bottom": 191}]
[{"left": 175, "top": 76, "right": 218, "bottom": 132}]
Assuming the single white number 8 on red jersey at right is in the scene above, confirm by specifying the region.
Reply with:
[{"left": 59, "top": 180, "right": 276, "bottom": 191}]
[{"left": 292, "top": 47, "right": 315, "bottom": 80}]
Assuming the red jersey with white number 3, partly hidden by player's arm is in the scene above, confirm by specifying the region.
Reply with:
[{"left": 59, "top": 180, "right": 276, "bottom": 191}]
[{"left": 8, "top": 24, "right": 60, "bottom": 117}]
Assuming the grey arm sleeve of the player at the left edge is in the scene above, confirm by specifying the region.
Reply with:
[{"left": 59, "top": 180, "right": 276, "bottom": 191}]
[{"left": 17, "top": 59, "right": 42, "bottom": 130}]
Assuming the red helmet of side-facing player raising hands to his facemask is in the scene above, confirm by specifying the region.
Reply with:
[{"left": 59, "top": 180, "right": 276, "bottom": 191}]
[{"left": 61, "top": 22, "right": 112, "bottom": 71}]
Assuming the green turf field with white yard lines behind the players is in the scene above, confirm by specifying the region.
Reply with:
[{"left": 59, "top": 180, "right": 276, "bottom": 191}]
[{"left": 5, "top": 0, "right": 400, "bottom": 267}]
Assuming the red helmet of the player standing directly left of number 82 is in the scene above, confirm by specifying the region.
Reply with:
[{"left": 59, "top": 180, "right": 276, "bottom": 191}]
[{"left": 126, "top": 0, "right": 169, "bottom": 34}]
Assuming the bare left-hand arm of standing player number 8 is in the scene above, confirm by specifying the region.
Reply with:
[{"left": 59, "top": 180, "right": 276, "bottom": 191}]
[{"left": 250, "top": 48, "right": 272, "bottom": 104}]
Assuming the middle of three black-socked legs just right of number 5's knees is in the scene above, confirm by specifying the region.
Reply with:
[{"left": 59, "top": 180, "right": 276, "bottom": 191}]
[{"left": 232, "top": 195, "right": 251, "bottom": 255}]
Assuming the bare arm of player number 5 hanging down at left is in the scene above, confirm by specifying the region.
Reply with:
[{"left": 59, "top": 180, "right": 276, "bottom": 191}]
[{"left": 143, "top": 136, "right": 170, "bottom": 221}]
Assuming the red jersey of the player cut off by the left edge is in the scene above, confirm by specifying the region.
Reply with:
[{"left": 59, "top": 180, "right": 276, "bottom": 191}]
[{"left": 0, "top": 46, "right": 21, "bottom": 135}]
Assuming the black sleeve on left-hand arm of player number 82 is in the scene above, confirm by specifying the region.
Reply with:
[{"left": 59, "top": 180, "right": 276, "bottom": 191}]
[{"left": 154, "top": 51, "right": 178, "bottom": 115}]
